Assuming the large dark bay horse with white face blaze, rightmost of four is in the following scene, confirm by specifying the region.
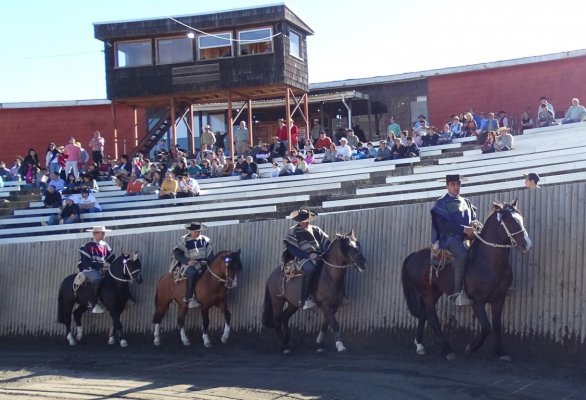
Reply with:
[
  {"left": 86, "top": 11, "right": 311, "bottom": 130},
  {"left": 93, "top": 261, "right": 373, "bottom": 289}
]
[{"left": 402, "top": 200, "right": 531, "bottom": 360}]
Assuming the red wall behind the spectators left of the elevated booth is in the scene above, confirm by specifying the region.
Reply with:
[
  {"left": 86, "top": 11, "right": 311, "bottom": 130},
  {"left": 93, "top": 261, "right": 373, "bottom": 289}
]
[{"left": 0, "top": 103, "right": 145, "bottom": 167}]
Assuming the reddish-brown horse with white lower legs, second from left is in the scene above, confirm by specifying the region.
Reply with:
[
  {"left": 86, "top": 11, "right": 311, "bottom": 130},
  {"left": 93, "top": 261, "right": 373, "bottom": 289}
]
[{"left": 153, "top": 250, "right": 242, "bottom": 347}]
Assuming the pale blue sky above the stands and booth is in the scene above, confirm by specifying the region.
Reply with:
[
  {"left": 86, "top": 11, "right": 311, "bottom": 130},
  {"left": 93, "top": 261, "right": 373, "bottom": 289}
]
[{"left": 0, "top": 0, "right": 586, "bottom": 103}]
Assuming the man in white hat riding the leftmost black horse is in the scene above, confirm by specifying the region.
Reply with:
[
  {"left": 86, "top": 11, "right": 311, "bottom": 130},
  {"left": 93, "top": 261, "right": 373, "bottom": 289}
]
[{"left": 77, "top": 226, "right": 116, "bottom": 314}]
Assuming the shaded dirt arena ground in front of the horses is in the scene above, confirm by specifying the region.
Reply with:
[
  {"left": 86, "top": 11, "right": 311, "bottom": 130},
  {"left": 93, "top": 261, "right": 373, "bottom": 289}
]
[{"left": 0, "top": 336, "right": 586, "bottom": 400}]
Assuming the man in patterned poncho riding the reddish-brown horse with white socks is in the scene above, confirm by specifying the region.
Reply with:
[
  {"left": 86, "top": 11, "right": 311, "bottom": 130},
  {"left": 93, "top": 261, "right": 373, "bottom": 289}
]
[{"left": 169, "top": 222, "right": 214, "bottom": 308}]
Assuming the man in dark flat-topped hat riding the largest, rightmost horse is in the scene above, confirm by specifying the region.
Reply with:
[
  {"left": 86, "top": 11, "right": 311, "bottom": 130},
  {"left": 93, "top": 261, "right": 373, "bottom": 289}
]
[{"left": 431, "top": 175, "right": 476, "bottom": 306}]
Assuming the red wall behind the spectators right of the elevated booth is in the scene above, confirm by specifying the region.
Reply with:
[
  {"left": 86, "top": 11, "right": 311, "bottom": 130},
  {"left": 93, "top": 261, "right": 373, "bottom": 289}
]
[{"left": 428, "top": 57, "right": 586, "bottom": 126}]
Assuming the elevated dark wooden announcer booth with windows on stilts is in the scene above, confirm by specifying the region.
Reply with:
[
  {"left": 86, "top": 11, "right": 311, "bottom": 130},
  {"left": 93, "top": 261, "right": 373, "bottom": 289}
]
[{"left": 94, "top": 4, "right": 313, "bottom": 155}]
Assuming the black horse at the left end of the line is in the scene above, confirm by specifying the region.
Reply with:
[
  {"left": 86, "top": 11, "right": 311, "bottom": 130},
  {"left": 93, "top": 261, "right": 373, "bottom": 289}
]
[{"left": 58, "top": 253, "right": 142, "bottom": 347}]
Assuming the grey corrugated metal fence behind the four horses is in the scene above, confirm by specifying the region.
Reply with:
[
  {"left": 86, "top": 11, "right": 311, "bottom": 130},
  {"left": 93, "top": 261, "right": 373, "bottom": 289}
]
[{"left": 0, "top": 183, "right": 586, "bottom": 344}]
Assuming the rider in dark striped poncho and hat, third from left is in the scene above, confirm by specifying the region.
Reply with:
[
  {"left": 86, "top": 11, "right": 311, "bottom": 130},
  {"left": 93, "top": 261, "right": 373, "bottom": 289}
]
[{"left": 282, "top": 208, "right": 330, "bottom": 310}]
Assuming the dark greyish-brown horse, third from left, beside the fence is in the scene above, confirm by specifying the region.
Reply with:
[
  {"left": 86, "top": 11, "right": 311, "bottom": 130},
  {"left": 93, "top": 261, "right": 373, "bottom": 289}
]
[{"left": 262, "top": 231, "right": 366, "bottom": 354}]
